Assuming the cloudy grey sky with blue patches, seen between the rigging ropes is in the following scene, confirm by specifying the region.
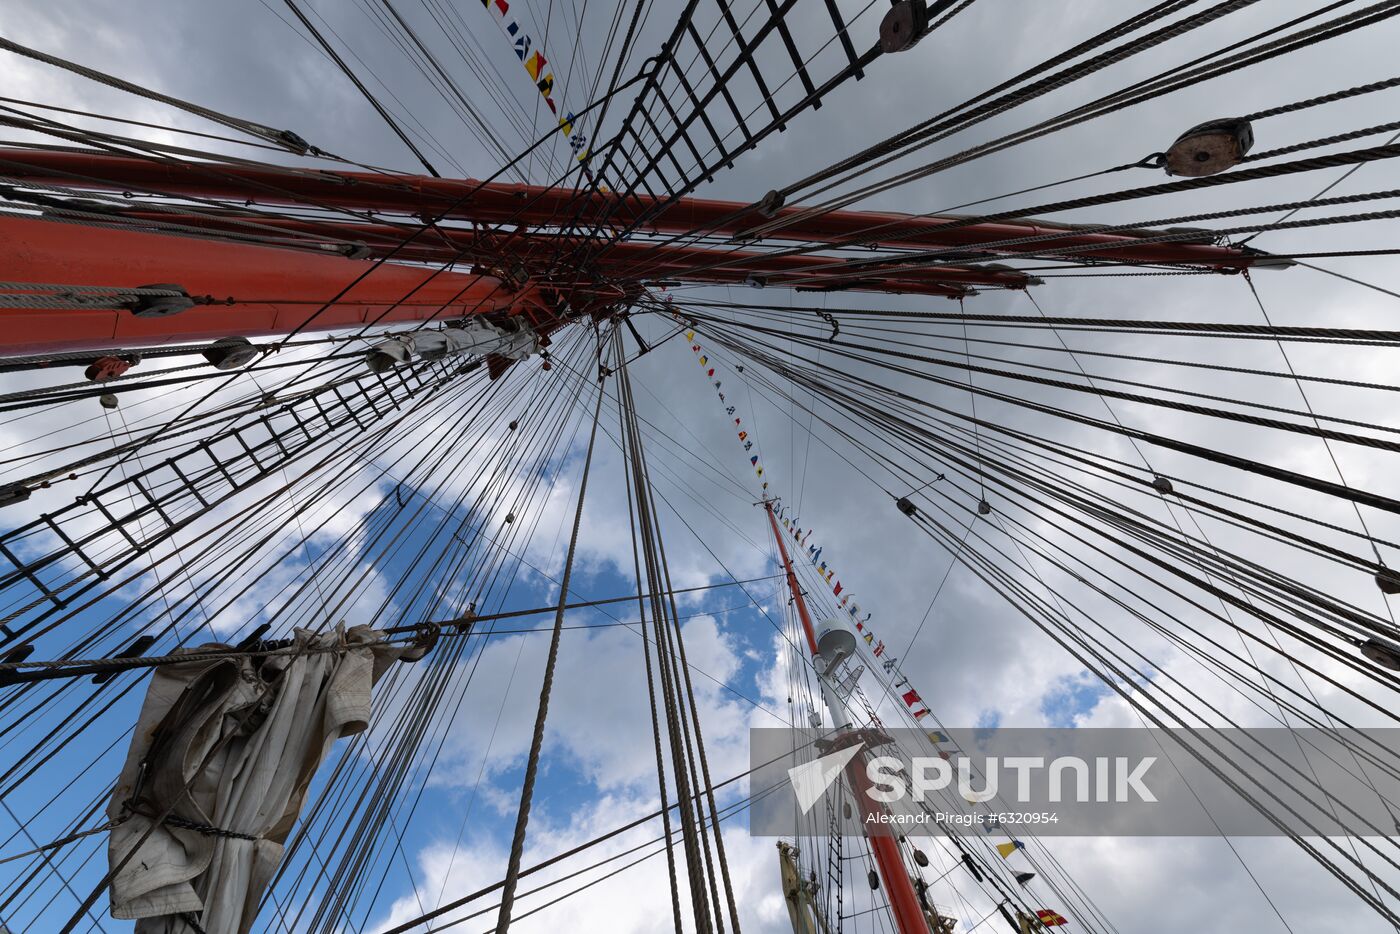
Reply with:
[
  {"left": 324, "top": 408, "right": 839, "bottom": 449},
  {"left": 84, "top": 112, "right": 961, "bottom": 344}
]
[{"left": 0, "top": 0, "right": 1400, "bottom": 934}]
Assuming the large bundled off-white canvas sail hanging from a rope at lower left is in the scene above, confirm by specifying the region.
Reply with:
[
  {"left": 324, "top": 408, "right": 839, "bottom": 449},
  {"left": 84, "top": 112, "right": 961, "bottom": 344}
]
[{"left": 108, "top": 626, "right": 413, "bottom": 934}]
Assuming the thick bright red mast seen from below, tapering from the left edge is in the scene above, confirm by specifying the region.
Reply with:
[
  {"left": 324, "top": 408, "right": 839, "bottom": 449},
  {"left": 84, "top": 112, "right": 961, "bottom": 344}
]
[{"left": 0, "top": 218, "right": 547, "bottom": 356}]
